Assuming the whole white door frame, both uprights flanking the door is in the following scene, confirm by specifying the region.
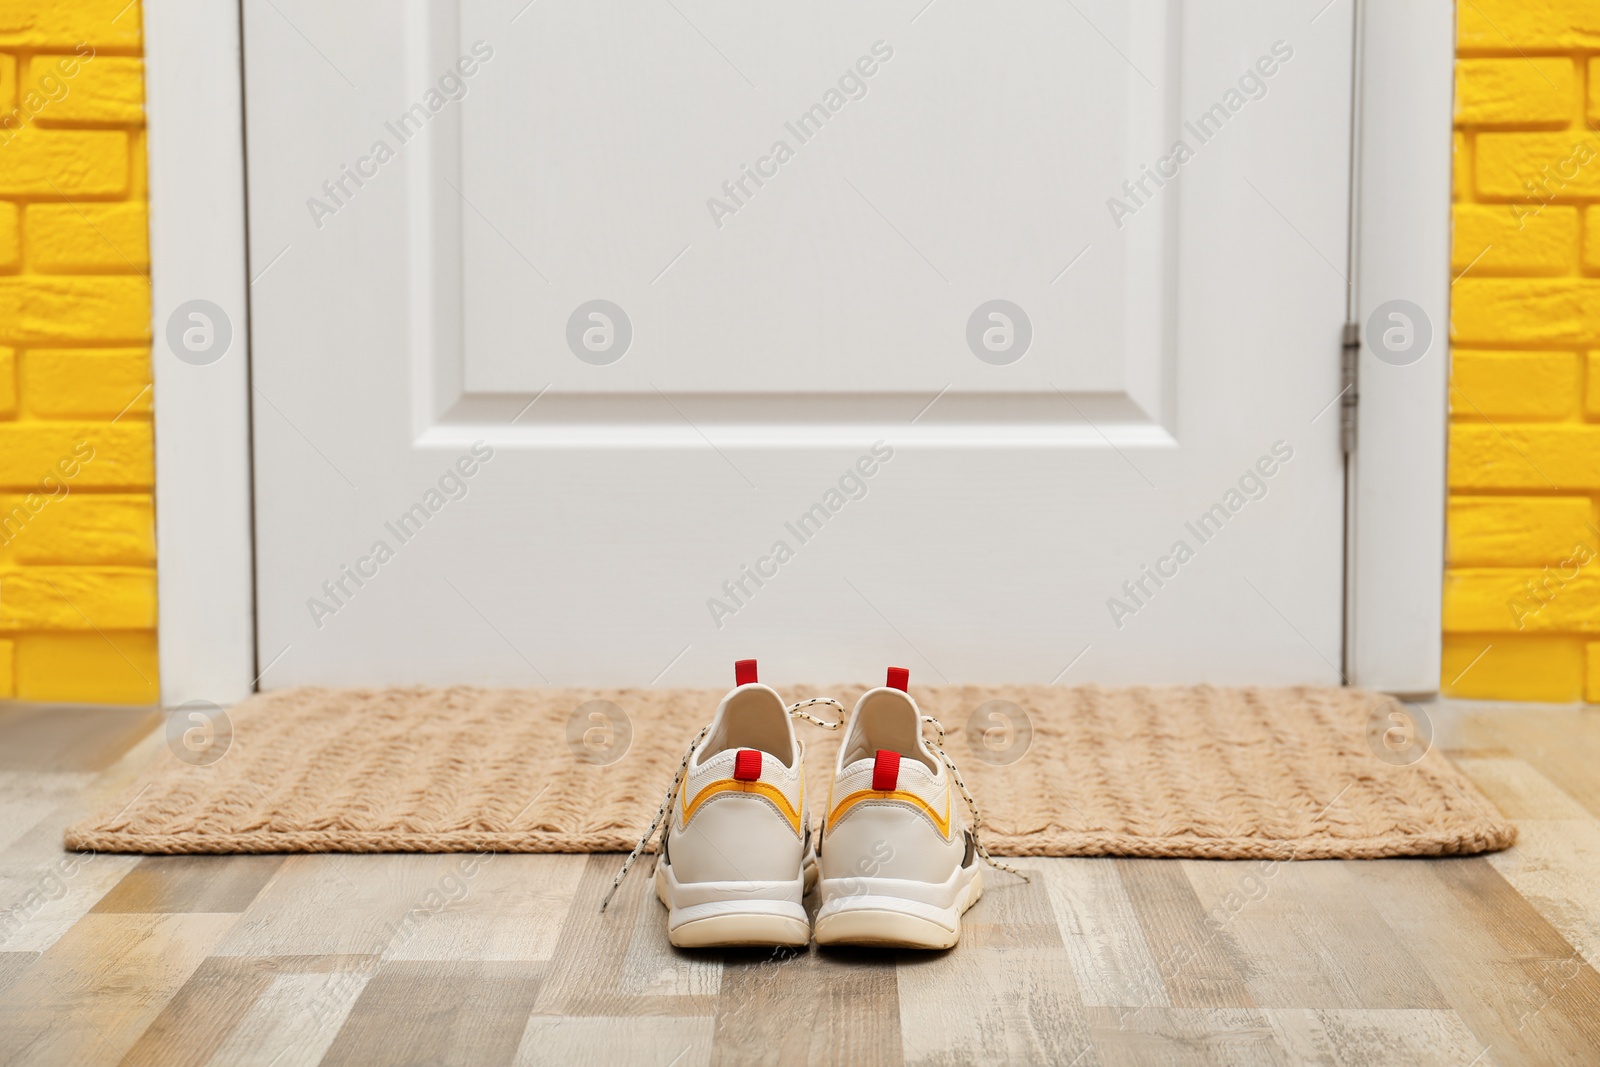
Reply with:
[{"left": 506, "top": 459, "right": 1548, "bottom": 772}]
[{"left": 144, "top": 0, "right": 1454, "bottom": 707}]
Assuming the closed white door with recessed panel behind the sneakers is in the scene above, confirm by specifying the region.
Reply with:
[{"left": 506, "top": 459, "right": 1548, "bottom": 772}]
[{"left": 245, "top": 0, "right": 1352, "bottom": 688}]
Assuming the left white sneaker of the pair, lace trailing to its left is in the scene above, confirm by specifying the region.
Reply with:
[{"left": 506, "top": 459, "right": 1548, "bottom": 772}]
[{"left": 602, "top": 659, "right": 816, "bottom": 949}]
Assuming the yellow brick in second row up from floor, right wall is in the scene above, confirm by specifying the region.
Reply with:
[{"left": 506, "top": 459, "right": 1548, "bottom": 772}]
[{"left": 1445, "top": 566, "right": 1600, "bottom": 633}]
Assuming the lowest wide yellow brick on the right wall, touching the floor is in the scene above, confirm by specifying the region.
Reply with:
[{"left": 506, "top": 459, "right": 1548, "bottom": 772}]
[{"left": 1440, "top": 633, "right": 1584, "bottom": 704}]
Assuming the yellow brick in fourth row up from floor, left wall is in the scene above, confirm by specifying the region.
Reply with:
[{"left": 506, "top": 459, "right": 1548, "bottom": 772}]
[{"left": 0, "top": 419, "right": 154, "bottom": 491}]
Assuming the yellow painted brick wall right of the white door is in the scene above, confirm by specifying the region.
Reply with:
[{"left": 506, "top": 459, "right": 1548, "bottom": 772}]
[{"left": 1440, "top": 0, "right": 1600, "bottom": 702}]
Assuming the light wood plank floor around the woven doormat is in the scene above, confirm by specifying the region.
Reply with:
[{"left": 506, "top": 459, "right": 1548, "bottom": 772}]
[{"left": 0, "top": 705, "right": 1600, "bottom": 1067}]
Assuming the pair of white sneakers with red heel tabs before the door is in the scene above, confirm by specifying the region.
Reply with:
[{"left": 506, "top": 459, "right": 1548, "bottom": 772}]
[{"left": 600, "top": 659, "right": 1011, "bottom": 949}]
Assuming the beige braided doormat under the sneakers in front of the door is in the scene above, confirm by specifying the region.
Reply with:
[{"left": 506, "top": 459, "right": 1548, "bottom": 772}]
[{"left": 66, "top": 686, "right": 1515, "bottom": 859}]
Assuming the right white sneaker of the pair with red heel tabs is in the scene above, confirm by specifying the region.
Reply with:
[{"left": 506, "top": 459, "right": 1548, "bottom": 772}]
[{"left": 814, "top": 667, "right": 984, "bottom": 949}]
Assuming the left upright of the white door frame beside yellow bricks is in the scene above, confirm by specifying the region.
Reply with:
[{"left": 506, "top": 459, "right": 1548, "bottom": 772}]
[{"left": 141, "top": 0, "right": 258, "bottom": 707}]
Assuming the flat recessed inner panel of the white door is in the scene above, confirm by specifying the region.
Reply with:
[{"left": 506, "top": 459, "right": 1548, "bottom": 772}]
[{"left": 457, "top": 0, "right": 1176, "bottom": 406}]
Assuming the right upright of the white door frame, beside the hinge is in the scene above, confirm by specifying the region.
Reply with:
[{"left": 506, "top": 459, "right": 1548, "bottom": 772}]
[{"left": 1336, "top": 0, "right": 1456, "bottom": 694}]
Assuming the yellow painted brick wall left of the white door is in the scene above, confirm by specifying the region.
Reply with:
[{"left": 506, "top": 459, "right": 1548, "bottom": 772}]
[{"left": 0, "top": 0, "right": 157, "bottom": 704}]
